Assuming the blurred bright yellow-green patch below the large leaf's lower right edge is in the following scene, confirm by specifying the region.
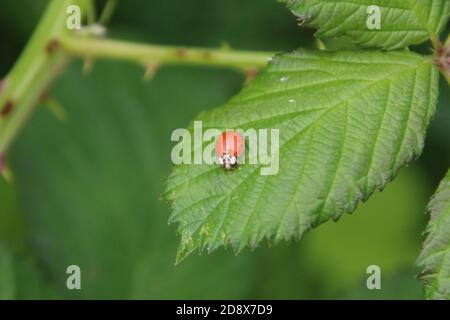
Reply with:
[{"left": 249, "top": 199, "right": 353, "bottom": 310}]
[{"left": 303, "top": 168, "right": 427, "bottom": 298}]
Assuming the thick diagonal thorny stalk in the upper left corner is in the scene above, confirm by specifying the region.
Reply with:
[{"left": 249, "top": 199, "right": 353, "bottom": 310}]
[{"left": 0, "top": 0, "right": 92, "bottom": 155}]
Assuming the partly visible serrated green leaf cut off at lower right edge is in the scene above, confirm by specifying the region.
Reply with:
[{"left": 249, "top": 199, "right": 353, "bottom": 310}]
[{"left": 417, "top": 170, "right": 450, "bottom": 300}]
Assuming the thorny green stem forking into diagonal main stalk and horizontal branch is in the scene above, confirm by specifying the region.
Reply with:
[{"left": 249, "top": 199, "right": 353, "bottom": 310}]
[{"left": 0, "top": 0, "right": 273, "bottom": 159}]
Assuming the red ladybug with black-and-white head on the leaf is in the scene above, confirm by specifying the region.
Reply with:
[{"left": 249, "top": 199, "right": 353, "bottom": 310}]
[{"left": 216, "top": 131, "right": 245, "bottom": 170}]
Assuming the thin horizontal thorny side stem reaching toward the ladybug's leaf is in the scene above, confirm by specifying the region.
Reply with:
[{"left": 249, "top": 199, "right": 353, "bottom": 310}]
[{"left": 58, "top": 37, "right": 274, "bottom": 71}]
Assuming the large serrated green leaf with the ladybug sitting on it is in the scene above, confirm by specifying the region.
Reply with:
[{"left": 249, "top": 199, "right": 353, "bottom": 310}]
[{"left": 165, "top": 50, "right": 438, "bottom": 261}]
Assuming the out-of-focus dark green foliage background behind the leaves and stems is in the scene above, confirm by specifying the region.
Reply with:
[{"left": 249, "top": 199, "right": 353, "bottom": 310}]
[{"left": 0, "top": 0, "right": 450, "bottom": 299}]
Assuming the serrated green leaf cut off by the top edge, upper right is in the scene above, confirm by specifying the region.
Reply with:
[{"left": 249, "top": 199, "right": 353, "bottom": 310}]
[{"left": 287, "top": 0, "right": 450, "bottom": 50}]
